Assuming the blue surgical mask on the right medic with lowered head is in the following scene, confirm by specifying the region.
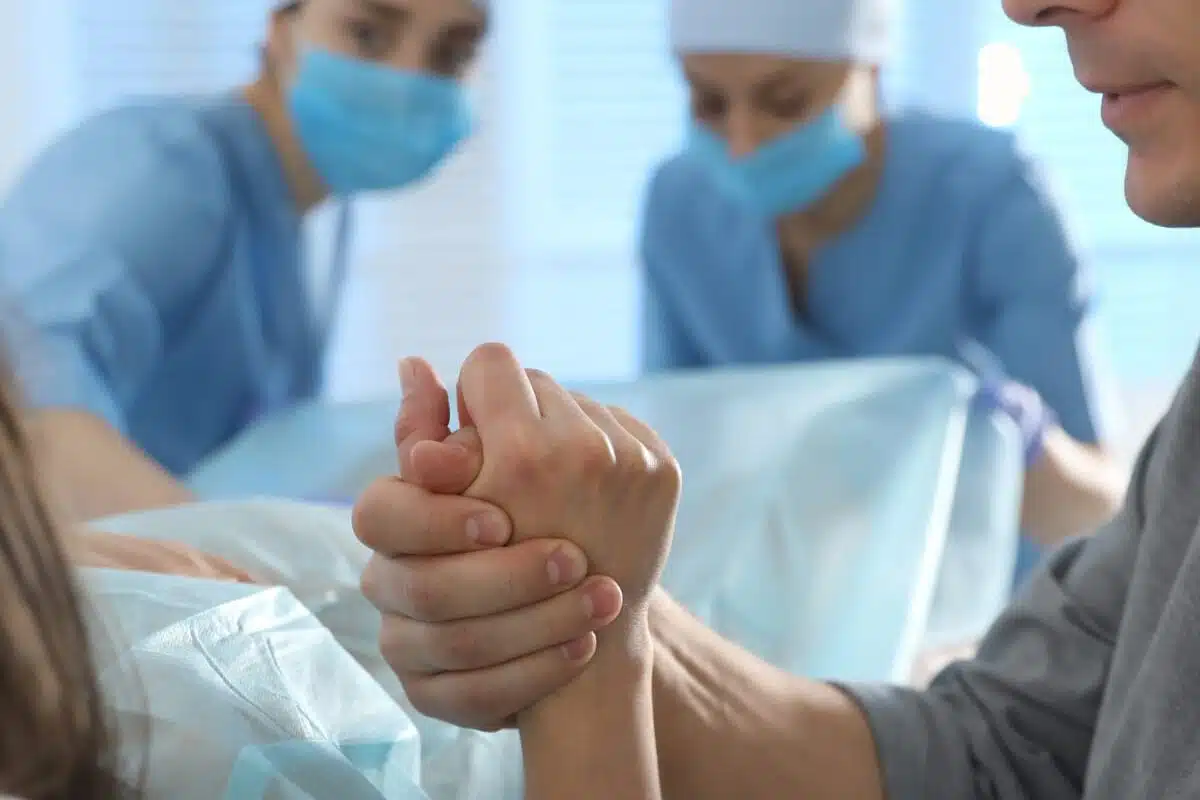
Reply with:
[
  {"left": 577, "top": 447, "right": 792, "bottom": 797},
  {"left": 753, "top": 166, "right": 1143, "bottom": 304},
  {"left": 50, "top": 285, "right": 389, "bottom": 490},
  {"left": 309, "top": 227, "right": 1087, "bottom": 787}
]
[{"left": 688, "top": 108, "right": 866, "bottom": 219}]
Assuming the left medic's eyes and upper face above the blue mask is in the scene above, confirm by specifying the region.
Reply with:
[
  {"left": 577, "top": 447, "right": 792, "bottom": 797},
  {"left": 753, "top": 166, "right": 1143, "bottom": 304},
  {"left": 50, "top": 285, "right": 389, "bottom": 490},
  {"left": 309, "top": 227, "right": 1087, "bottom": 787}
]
[{"left": 271, "top": 0, "right": 487, "bottom": 78}]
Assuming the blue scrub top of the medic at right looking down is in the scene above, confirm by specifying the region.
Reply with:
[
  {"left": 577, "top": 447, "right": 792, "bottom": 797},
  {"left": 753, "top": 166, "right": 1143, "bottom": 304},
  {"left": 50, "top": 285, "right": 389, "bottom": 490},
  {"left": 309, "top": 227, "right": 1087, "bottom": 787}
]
[{"left": 642, "top": 114, "right": 1114, "bottom": 443}]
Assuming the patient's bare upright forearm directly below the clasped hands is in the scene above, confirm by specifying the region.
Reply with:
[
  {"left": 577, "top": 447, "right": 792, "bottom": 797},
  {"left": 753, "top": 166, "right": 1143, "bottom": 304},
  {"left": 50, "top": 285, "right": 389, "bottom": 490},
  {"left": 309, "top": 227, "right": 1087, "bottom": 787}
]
[{"left": 520, "top": 645, "right": 662, "bottom": 800}]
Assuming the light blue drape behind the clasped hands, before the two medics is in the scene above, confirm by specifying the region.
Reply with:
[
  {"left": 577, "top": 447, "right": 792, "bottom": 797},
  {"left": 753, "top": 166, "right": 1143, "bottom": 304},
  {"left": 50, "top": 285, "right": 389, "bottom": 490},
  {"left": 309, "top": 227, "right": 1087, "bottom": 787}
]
[{"left": 190, "top": 360, "right": 1021, "bottom": 680}]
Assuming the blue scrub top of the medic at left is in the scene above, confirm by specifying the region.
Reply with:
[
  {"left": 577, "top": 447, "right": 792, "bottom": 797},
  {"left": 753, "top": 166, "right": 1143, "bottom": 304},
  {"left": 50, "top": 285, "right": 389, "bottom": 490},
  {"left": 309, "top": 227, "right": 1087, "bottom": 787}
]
[{"left": 0, "top": 96, "right": 325, "bottom": 475}]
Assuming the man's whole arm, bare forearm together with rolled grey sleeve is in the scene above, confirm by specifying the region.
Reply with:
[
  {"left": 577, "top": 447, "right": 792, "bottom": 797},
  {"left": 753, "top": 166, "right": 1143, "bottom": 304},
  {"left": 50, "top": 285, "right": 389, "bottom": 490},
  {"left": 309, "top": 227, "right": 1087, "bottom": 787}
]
[{"left": 653, "top": 419, "right": 1157, "bottom": 800}]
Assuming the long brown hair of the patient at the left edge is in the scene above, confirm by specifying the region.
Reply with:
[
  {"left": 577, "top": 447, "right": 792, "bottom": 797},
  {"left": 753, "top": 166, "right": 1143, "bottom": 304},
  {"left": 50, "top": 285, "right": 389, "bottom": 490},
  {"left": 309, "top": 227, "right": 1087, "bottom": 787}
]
[{"left": 0, "top": 355, "right": 130, "bottom": 800}]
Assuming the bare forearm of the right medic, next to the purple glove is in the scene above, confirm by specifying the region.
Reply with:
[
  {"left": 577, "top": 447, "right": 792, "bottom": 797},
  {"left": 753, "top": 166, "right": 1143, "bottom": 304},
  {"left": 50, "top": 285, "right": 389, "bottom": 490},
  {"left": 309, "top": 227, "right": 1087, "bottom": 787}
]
[{"left": 1021, "top": 428, "right": 1128, "bottom": 546}]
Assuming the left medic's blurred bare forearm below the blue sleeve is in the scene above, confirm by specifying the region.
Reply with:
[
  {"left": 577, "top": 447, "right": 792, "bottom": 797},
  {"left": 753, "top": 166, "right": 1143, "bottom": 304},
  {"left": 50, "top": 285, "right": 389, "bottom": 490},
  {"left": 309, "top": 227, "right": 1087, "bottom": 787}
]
[{"left": 30, "top": 409, "right": 193, "bottom": 522}]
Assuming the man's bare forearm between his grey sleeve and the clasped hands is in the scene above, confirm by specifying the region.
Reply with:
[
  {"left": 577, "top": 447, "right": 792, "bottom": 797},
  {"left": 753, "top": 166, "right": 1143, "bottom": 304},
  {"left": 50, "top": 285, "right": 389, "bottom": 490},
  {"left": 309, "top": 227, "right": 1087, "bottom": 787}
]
[{"left": 652, "top": 593, "right": 883, "bottom": 800}]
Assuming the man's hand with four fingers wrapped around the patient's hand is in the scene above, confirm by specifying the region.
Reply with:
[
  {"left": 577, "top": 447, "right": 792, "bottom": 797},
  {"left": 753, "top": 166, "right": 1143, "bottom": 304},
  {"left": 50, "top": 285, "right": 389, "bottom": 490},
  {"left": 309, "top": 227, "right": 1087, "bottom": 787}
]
[{"left": 354, "top": 359, "right": 622, "bottom": 730}]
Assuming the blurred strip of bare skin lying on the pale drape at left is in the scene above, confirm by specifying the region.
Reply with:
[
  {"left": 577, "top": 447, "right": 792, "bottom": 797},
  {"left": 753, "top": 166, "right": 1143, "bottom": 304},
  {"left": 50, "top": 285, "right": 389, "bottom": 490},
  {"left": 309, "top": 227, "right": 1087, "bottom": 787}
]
[{"left": 66, "top": 531, "right": 254, "bottom": 583}]
